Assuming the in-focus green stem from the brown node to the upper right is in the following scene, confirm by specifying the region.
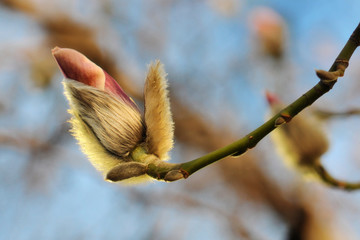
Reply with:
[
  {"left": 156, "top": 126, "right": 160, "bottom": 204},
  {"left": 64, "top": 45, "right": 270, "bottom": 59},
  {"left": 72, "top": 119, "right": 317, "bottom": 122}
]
[{"left": 177, "top": 24, "right": 360, "bottom": 177}]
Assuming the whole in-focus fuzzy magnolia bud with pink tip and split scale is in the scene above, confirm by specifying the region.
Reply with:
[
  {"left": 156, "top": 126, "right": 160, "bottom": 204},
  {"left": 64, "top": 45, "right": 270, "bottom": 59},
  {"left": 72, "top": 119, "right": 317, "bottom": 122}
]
[{"left": 52, "top": 47, "right": 173, "bottom": 181}]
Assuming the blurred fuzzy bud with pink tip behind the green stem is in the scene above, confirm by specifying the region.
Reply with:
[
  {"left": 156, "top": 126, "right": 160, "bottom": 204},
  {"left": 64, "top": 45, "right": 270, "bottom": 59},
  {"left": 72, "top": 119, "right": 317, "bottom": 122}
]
[{"left": 266, "top": 92, "right": 329, "bottom": 172}]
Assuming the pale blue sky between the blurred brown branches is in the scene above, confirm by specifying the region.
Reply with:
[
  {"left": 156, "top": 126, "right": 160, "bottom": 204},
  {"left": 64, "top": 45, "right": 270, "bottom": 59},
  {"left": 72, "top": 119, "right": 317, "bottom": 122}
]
[{"left": 0, "top": 0, "right": 360, "bottom": 240}]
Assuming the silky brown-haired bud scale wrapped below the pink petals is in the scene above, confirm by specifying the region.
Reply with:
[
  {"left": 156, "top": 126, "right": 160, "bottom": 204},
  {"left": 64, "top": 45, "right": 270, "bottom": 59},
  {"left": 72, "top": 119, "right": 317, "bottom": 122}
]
[{"left": 64, "top": 79, "right": 144, "bottom": 157}]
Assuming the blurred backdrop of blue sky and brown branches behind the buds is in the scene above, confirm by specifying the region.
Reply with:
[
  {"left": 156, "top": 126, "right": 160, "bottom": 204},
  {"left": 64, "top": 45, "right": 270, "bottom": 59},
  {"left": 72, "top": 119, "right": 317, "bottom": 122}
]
[{"left": 0, "top": 0, "right": 360, "bottom": 240}]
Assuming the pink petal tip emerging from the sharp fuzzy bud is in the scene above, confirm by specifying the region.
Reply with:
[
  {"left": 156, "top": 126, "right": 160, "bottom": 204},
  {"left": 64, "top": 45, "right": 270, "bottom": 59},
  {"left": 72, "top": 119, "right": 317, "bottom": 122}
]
[{"left": 52, "top": 47, "right": 137, "bottom": 108}]
